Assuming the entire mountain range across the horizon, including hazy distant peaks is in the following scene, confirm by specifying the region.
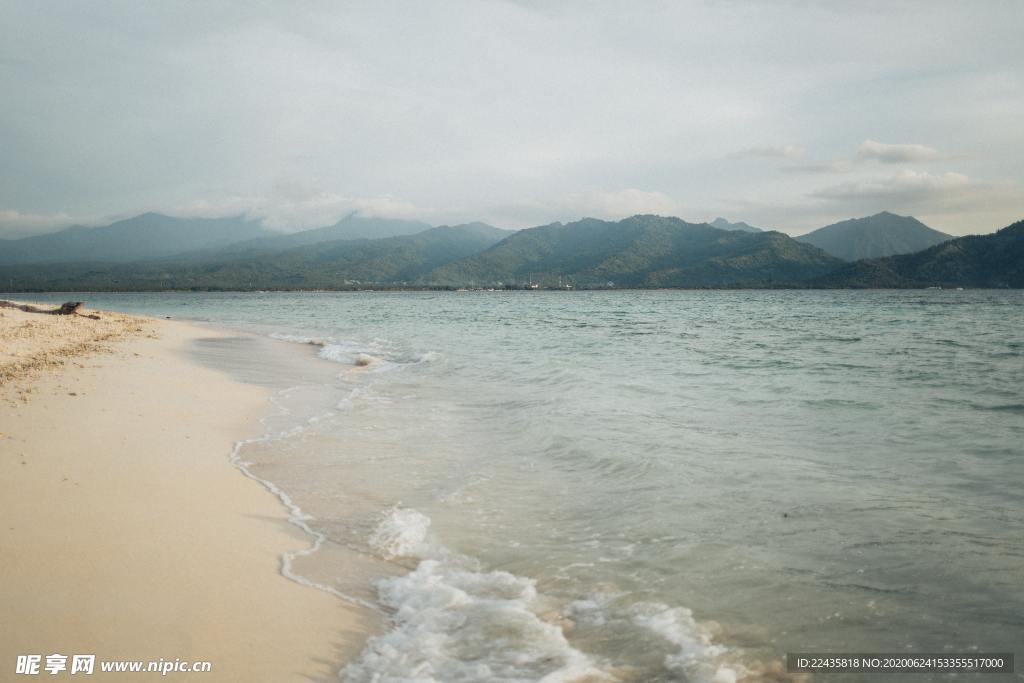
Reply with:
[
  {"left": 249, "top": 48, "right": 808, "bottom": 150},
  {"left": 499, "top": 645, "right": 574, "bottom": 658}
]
[{"left": 0, "top": 212, "right": 1024, "bottom": 291}]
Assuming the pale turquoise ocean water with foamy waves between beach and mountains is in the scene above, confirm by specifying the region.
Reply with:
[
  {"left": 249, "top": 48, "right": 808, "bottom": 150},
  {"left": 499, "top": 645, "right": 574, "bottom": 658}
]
[{"left": 16, "top": 291, "right": 1024, "bottom": 683}]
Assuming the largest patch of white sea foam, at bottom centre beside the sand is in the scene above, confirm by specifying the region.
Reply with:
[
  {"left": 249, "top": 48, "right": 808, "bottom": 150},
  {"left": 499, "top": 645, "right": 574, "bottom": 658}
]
[{"left": 342, "top": 508, "right": 613, "bottom": 683}]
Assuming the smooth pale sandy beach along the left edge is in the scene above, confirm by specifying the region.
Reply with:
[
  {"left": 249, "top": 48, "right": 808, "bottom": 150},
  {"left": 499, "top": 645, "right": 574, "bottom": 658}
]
[{"left": 0, "top": 309, "right": 367, "bottom": 681}]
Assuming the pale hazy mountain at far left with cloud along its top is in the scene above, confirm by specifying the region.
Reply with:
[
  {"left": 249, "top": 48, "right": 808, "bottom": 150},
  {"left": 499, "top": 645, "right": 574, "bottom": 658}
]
[{"left": 0, "top": 213, "right": 270, "bottom": 264}]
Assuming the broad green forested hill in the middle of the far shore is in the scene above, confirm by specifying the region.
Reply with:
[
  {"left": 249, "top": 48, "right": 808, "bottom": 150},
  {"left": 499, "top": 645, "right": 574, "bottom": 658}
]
[{"left": 420, "top": 215, "right": 840, "bottom": 287}]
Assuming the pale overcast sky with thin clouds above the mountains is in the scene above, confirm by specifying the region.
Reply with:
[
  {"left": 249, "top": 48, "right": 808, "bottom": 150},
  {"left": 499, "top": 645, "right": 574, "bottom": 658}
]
[{"left": 0, "top": 0, "right": 1024, "bottom": 238}]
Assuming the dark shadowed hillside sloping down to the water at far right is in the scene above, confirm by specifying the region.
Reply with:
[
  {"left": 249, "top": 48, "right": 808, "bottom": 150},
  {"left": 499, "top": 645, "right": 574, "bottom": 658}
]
[{"left": 813, "top": 221, "right": 1024, "bottom": 288}]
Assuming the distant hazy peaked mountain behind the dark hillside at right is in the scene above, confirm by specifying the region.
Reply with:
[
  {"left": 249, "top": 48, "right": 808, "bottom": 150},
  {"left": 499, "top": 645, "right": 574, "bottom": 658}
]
[{"left": 797, "top": 211, "right": 952, "bottom": 261}]
